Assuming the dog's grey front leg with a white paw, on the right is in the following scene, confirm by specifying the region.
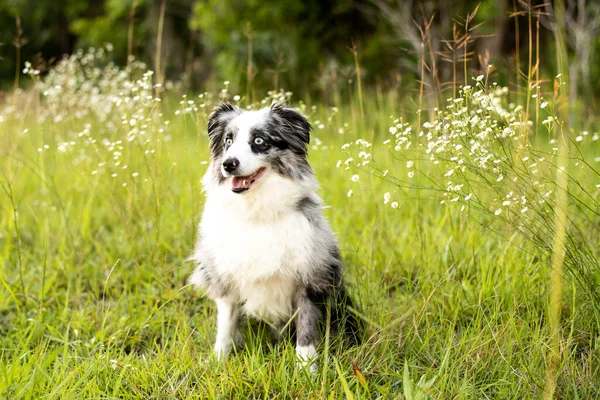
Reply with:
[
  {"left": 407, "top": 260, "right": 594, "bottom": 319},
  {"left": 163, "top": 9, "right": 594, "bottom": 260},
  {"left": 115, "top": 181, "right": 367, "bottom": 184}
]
[{"left": 296, "top": 292, "right": 322, "bottom": 372}]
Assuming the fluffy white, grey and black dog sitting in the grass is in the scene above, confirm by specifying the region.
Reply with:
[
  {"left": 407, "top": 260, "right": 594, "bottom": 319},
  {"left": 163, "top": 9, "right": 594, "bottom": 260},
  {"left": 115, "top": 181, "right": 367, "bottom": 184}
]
[{"left": 190, "top": 103, "right": 358, "bottom": 371}]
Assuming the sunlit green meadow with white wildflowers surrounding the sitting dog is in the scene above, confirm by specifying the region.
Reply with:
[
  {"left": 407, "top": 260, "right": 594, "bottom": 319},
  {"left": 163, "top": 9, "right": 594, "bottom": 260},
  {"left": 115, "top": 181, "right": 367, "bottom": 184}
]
[{"left": 0, "top": 45, "right": 600, "bottom": 399}]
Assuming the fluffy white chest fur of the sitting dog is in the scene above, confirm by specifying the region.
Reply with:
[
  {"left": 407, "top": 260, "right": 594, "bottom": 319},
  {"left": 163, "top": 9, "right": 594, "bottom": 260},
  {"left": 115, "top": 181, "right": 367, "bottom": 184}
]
[{"left": 200, "top": 173, "right": 319, "bottom": 322}]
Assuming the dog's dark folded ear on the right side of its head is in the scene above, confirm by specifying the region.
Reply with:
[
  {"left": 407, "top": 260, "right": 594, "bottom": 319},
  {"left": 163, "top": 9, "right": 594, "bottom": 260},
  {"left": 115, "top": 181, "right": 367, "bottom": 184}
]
[{"left": 271, "top": 102, "right": 311, "bottom": 154}]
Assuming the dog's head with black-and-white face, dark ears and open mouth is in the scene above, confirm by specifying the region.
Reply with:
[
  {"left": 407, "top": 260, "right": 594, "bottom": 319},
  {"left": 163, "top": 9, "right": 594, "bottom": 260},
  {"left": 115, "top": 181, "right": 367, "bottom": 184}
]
[{"left": 208, "top": 103, "right": 310, "bottom": 193}]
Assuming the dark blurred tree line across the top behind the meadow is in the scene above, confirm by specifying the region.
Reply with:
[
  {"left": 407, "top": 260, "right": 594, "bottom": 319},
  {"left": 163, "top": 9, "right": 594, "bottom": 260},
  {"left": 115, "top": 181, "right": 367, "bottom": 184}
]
[{"left": 0, "top": 0, "right": 600, "bottom": 103}]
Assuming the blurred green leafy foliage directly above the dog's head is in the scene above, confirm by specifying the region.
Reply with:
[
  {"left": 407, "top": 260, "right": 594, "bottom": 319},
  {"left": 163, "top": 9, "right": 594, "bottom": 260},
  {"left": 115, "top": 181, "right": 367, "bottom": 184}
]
[{"left": 191, "top": 0, "right": 376, "bottom": 97}]
